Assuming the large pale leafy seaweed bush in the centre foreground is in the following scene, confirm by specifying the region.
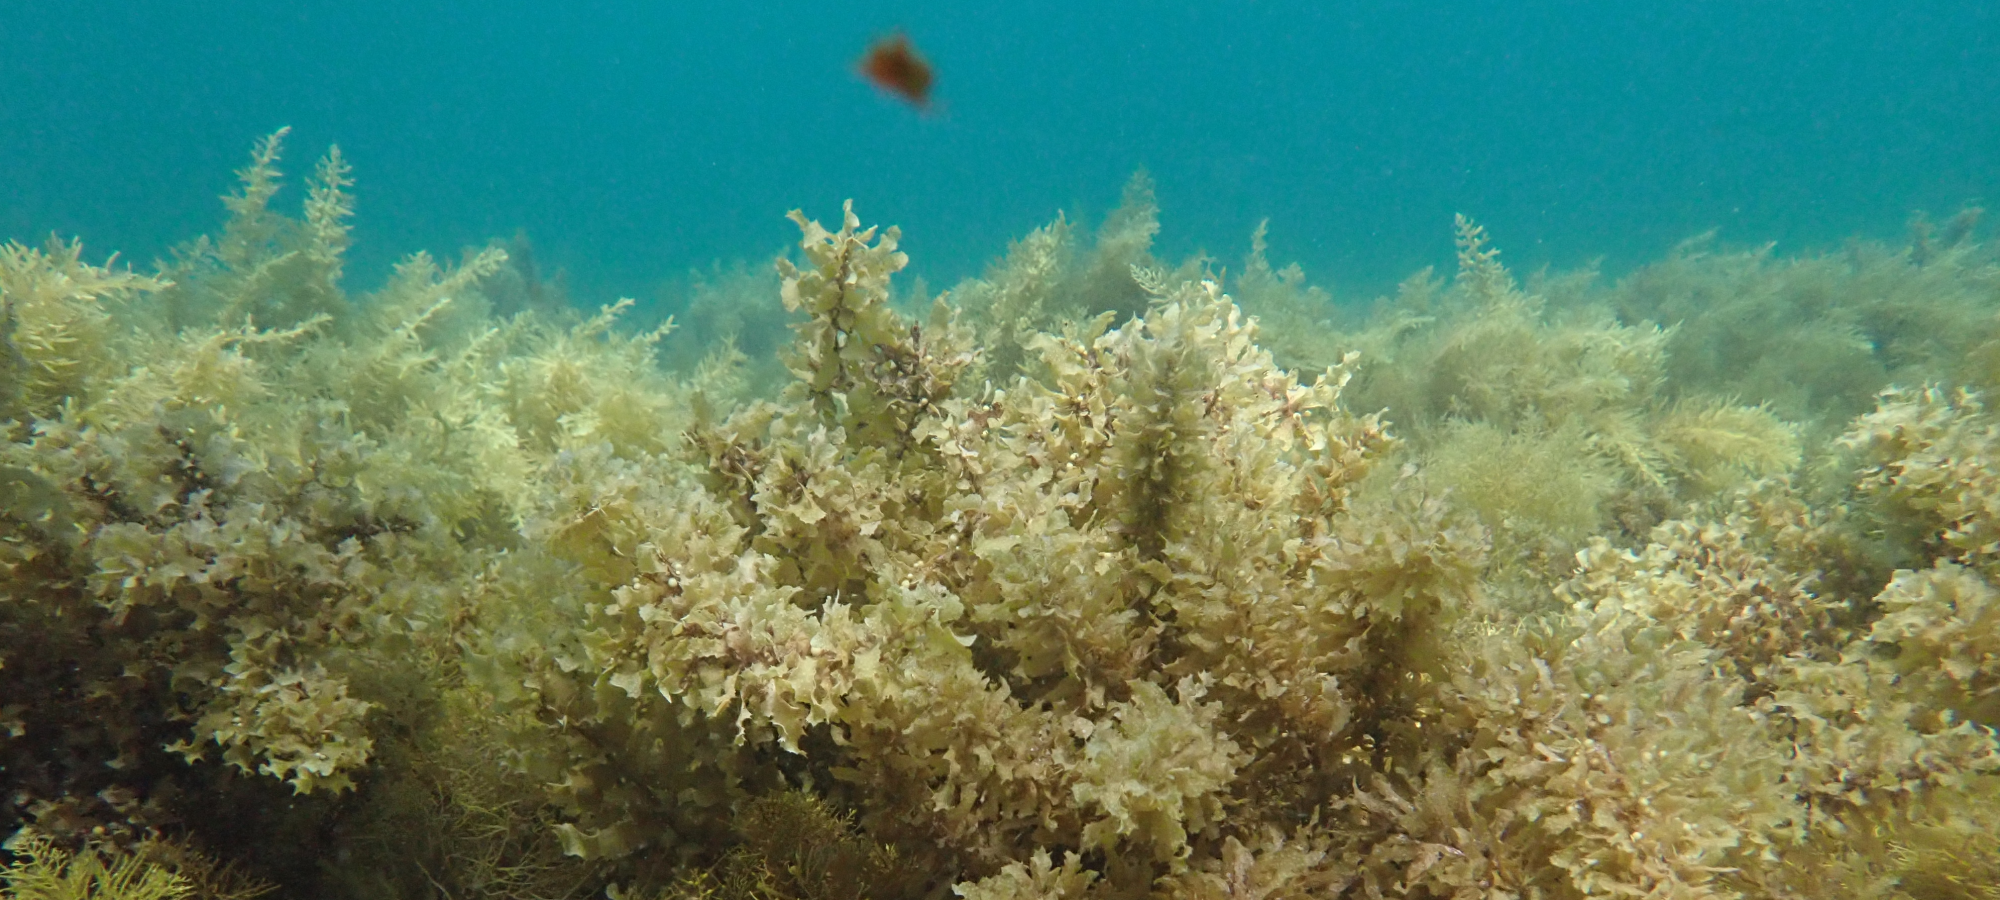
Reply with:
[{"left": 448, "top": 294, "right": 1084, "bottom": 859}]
[{"left": 492, "top": 197, "right": 1482, "bottom": 890}]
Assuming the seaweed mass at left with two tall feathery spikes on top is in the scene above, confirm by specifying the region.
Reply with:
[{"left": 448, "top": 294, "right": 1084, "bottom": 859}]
[{"left": 0, "top": 132, "right": 682, "bottom": 896}]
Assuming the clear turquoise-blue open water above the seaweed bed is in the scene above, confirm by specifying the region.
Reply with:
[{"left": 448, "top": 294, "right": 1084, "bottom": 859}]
[{"left": 0, "top": 0, "right": 2000, "bottom": 304}]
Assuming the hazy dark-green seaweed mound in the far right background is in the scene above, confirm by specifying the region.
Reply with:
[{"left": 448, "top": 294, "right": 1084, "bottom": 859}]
[{"left": 1602, "top": 206, "right": 2000, "bottom": 438}]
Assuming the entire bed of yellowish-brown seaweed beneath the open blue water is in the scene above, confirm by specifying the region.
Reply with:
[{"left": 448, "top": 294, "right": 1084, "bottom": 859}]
[{"left": 0, "top": 132, "right": 2000, "bottom": 900}]
